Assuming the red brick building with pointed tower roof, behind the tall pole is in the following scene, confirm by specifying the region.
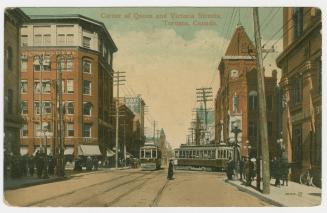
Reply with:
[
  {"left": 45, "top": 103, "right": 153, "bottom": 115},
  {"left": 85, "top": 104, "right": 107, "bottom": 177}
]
[{"left": 215, "top": 26, "right": 279, "bottom": 156}]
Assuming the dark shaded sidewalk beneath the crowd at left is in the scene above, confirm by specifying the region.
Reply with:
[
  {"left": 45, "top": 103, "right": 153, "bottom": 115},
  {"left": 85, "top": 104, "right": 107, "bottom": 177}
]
[{"left": 3, "top": 176, "right": 67, "bottom": 190}]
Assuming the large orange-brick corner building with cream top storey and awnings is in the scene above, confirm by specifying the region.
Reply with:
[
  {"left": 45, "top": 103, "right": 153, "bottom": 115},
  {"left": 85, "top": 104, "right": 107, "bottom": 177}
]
[{"left": 20, "top": 15, "right": 117, "bottom": 156}]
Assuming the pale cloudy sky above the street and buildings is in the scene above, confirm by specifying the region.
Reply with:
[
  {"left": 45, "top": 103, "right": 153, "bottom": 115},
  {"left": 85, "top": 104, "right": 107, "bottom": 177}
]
[{"left": 22, "top": 7, "right": 283, "bottom": 148}]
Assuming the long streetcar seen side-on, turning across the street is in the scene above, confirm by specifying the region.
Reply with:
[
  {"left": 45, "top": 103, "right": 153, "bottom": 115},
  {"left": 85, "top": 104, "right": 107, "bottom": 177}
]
[{"left": 174, "top": 145, "right": 234, "bottom": 171}]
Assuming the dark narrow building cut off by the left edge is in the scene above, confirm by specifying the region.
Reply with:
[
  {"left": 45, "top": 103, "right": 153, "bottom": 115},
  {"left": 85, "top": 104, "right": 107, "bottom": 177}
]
[{"left": 3, "top": 8, "right": 29, "bottom": 155}]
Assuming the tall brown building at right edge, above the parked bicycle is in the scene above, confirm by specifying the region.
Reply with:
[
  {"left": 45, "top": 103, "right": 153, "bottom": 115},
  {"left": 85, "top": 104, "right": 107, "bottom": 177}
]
[{"left": 277, "top": 8, "right": 322, "bottom": 186}]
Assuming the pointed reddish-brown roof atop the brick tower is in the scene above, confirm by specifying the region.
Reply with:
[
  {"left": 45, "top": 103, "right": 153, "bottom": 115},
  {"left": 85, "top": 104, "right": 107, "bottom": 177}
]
[{"left": 225, "top": 26, "right": 255, "bottom": 56}]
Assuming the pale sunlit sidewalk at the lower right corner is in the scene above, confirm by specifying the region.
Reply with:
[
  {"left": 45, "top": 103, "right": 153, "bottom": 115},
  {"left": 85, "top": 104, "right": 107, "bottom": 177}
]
[{"left": 226, "top": 179, "right": 321, "bottom": 207}]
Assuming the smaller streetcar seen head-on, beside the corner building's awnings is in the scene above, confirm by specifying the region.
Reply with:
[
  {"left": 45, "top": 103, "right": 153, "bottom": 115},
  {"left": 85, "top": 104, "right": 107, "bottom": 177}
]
[{"left": 140, "top": 144, "right": 161, "bottom": 170}]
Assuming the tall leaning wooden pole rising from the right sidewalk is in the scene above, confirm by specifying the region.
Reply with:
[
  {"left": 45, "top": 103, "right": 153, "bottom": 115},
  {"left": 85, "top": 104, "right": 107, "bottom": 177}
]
[{"left": 253, "top": 7, "right": 270, "bottom": 194}]
